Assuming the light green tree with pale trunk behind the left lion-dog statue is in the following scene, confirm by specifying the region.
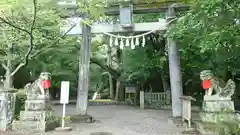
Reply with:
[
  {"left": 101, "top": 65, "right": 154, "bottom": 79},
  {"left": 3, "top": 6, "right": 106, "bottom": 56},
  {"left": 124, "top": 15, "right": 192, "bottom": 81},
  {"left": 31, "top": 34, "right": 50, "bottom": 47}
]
[{"left": 0, "top": 0, "right": 76, "bottom": 88}]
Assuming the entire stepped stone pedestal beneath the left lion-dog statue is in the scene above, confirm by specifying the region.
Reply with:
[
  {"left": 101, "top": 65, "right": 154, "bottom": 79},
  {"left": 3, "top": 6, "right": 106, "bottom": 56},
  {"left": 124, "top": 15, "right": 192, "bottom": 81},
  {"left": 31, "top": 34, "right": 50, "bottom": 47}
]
[{"left": 13, "top": 100, "right": 59, "bottom": 132}]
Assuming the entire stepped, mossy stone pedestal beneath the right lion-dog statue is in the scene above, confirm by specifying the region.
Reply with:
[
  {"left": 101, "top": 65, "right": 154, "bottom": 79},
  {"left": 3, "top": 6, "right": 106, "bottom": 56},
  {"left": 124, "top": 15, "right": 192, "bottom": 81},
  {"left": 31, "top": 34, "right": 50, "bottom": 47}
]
[{"left": 196, "top": 97, "right": 239, "bottom": 135}]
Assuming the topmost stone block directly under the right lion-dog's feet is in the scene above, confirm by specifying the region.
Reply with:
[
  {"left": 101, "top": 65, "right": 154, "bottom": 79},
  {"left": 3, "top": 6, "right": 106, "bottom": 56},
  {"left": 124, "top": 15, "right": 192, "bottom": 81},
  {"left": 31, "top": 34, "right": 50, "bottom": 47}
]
[{"left": 202, "top": 100, "right": 235, "bottom": 112}]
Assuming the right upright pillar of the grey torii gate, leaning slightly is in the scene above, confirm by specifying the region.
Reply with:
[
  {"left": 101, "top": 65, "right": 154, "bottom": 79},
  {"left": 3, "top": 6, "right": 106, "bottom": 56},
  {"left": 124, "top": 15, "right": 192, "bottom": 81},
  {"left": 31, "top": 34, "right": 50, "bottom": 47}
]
[{"left": 167, "top": 7, "right": 183, "bottom": 117}]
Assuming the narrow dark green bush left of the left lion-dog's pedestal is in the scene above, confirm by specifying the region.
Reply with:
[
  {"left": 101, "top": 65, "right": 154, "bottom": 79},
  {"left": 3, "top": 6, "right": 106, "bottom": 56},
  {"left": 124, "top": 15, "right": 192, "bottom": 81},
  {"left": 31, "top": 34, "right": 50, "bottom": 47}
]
[{"left": 14, "top": 89, "right": 26, "bottom": 120}]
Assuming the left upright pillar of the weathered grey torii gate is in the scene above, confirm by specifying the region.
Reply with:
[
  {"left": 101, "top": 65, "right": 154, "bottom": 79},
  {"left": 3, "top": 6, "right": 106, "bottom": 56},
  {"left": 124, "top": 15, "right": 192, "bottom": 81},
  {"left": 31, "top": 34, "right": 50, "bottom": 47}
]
[{"left": 76, "top": 24, "right": 91, "bottom": 115}]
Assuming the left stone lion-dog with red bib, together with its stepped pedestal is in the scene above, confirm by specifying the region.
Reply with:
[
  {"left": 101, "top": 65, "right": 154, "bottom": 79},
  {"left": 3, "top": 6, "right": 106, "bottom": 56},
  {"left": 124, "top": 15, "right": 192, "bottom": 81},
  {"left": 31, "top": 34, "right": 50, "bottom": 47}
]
[{"left": 13, "top": 72, "right": 58, "bottom": 132}]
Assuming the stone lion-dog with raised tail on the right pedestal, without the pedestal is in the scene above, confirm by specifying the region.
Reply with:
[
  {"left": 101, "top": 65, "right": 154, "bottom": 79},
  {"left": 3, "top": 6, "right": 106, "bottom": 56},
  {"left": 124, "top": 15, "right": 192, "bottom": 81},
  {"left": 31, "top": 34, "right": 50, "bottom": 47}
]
[{"left": 200, "top": 70, "right": 236, "bottom": 99}]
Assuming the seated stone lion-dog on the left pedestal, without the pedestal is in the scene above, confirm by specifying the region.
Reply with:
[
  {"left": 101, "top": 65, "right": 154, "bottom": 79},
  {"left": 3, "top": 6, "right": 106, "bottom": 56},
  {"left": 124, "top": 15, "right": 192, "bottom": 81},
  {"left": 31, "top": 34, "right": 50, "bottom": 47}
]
[{"left": 24, "top": 72, "right": 51, "bottom": 100}]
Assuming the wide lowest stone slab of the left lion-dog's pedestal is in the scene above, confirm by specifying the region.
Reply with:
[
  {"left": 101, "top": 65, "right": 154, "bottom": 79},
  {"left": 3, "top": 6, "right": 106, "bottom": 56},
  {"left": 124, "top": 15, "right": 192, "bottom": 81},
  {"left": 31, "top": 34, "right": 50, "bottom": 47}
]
[{"left": 13, "top": 119, "right": 59, "bottom": 132}]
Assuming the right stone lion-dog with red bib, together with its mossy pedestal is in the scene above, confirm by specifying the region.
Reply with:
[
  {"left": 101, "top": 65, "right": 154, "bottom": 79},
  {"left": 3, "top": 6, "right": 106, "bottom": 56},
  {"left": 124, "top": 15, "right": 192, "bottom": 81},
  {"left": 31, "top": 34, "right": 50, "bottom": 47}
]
[{"left": 196, "top": 70, "right": 237, "bottom": 135}]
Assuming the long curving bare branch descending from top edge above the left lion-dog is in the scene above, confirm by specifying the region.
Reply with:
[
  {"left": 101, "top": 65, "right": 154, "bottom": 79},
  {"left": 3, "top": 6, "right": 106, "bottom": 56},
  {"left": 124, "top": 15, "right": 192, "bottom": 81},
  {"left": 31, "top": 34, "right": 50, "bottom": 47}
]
[{"left": 11, "top": 0, "right": 37, "bottom": 76}]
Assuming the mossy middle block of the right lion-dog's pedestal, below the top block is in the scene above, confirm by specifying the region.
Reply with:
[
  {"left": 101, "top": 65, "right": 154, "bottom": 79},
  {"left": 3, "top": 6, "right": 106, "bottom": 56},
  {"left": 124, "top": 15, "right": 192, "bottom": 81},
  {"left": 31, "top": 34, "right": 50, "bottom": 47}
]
[{"left": 199, "top": 112, "right": 236, "bottom": 123}]
